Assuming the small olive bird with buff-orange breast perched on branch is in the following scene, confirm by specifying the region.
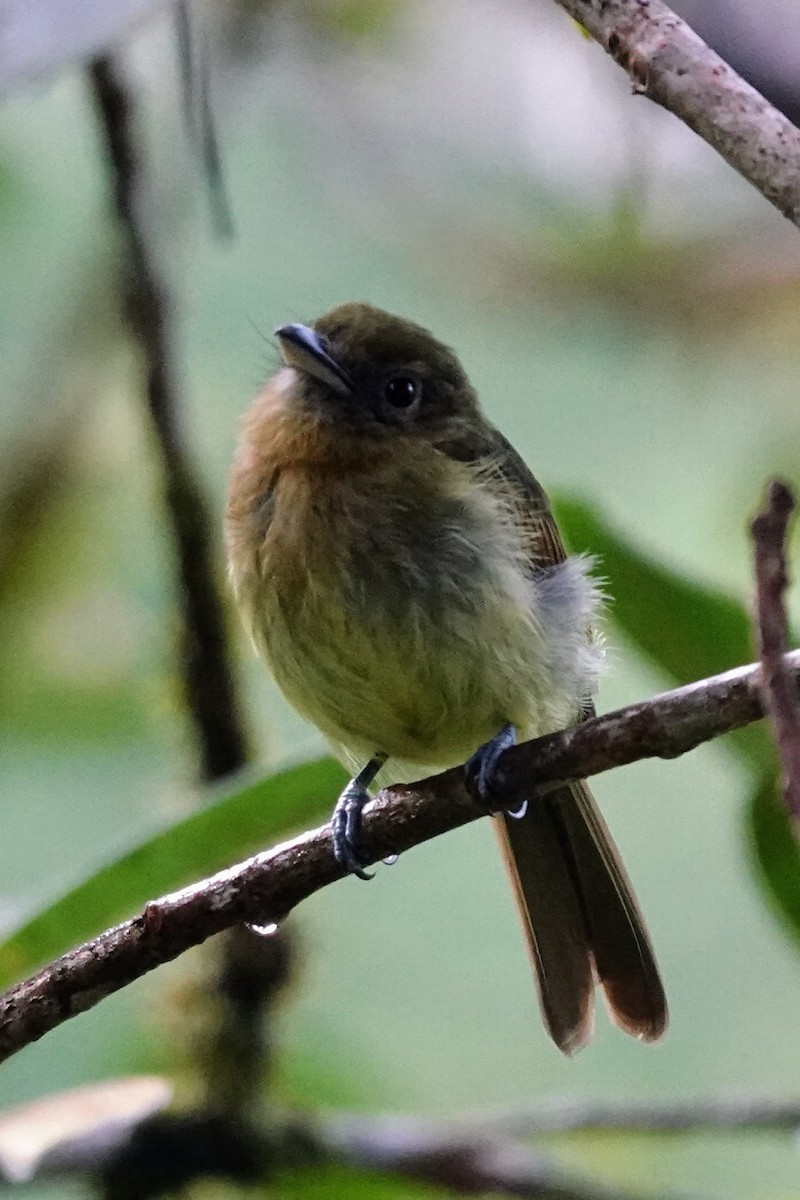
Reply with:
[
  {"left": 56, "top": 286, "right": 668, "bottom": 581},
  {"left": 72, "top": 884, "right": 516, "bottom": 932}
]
[{"left": 225, "top": 302, "right": 668, "bottom": 1055}]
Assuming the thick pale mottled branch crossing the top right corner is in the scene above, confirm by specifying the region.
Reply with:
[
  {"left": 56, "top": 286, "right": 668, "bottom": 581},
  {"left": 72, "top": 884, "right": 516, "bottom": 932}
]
[{"left": 557, "top": 0, "right": 800, "bottom": 226}]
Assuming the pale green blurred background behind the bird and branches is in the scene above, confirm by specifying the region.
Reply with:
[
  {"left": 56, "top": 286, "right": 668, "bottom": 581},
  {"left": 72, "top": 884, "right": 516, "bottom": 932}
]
[{"left": 0, "top": 0, "right": 800, "bottom": 1198}]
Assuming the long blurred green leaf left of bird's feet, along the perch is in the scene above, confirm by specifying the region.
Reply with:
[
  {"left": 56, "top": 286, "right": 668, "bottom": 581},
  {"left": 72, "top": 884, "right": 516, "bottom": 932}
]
[{"left": 0, "top": 758, "right": 344, "bottom": 986}]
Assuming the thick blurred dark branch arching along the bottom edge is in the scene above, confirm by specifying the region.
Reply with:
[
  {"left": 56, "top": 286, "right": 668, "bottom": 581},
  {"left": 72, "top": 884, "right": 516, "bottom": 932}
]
[{"left": 14, "top": 1099, "right": 714, "bottom": 1200}]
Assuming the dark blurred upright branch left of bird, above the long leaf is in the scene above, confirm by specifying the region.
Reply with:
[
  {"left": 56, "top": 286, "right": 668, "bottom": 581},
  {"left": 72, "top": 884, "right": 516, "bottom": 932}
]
[{"left": 89, "top": 55, "right": 246, "bottom": 780}]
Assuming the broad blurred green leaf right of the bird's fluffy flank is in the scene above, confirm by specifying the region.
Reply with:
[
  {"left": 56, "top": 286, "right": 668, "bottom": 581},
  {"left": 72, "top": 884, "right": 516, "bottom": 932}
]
[{"left": 555, "top": 497, "right": 770, "bottom": 773}]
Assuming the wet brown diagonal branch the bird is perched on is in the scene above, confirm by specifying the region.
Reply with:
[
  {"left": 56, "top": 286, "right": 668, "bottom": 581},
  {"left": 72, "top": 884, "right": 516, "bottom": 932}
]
[{"left": 0, "top": 650, "right": 800, "bottom": 1062}]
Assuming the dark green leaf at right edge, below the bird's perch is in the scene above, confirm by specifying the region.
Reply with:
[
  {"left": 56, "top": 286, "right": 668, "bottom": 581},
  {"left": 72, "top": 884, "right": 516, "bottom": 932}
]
[{"left": 748, "top": 775, "right": 800, "bottom": 941}]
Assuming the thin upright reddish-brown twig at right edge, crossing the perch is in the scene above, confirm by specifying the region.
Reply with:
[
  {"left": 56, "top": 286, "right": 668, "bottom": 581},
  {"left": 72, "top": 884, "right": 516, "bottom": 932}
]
[{"left": 751, "top": 480, "right": 800, "bottom": 823}]
